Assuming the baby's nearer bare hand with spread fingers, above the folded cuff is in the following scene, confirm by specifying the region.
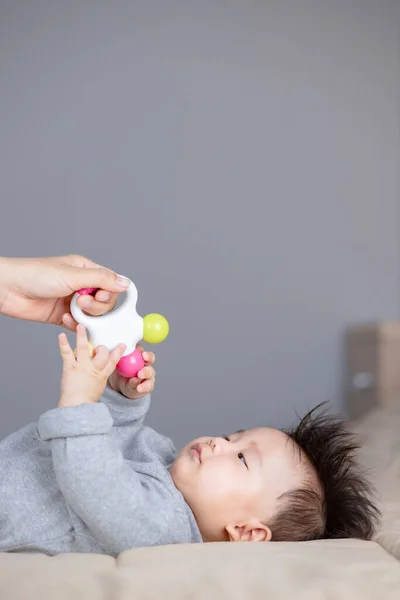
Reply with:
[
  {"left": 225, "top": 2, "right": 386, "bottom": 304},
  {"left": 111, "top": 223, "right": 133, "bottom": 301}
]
[{"left": 58, "top": 325, "right": 125, "bottom": 407}]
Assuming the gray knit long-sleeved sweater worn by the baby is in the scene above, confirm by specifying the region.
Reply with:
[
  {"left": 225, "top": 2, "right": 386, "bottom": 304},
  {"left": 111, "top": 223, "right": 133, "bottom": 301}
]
[{"left": 0, "top": 389, "right": 202, "bottom": 556}]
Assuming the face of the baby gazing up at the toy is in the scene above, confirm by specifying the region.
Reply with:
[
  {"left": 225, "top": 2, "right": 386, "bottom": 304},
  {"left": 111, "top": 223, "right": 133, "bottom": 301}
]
[{"left": 170, "top": 427, "right": 308, "bottom": 541}]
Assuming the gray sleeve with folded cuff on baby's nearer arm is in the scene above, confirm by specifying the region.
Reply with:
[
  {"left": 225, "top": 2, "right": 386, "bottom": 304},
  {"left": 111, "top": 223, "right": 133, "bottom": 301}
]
[{"left": 38, "top": 403, "right": 171, "bottom": 555}]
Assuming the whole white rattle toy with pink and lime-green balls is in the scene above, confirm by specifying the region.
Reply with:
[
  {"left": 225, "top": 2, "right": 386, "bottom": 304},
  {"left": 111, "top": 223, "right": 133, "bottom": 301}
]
[{"left": 71, "top": 281, "right": 169, "bottom": 378}]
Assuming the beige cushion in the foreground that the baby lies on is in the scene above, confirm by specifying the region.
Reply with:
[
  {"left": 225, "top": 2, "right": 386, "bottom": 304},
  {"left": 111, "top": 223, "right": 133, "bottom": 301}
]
[{"left": 0, "top": 540, "right": 400, "bottom": 600}]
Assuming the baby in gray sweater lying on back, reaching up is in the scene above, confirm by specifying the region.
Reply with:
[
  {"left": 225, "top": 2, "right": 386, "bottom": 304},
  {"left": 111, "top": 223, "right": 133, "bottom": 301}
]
[{"left": 0, "top": 325, "right": 379, "bottom": 556}]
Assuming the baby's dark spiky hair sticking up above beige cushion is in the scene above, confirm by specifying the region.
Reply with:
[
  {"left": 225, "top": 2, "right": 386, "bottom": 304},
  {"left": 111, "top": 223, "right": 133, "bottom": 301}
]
[{"left": 268, "top": 405, "right": 380, "bottom": 541}]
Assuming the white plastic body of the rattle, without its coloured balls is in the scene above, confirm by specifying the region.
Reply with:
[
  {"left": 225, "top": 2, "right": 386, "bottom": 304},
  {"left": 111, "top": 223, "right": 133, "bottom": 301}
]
[{"left": 71, "top": 281, "right": 143, "bottom": 356}]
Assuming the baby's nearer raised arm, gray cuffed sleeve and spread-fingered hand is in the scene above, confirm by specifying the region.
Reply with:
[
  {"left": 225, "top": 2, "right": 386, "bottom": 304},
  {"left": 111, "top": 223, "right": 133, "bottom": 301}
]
[{"left": 44, "top": 325, "right": 171, "bottom": 554}]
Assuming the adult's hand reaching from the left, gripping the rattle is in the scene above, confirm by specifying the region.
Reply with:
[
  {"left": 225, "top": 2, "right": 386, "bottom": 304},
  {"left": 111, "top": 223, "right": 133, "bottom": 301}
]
[{"left": 0, "top": 255, "right": 129, "bottom": 331}]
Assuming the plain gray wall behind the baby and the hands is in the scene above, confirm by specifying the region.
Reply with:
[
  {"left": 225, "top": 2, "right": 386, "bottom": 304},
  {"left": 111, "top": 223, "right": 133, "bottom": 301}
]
[{"left": 0, "top": 0, "right": 400, "bottom": 444}]
